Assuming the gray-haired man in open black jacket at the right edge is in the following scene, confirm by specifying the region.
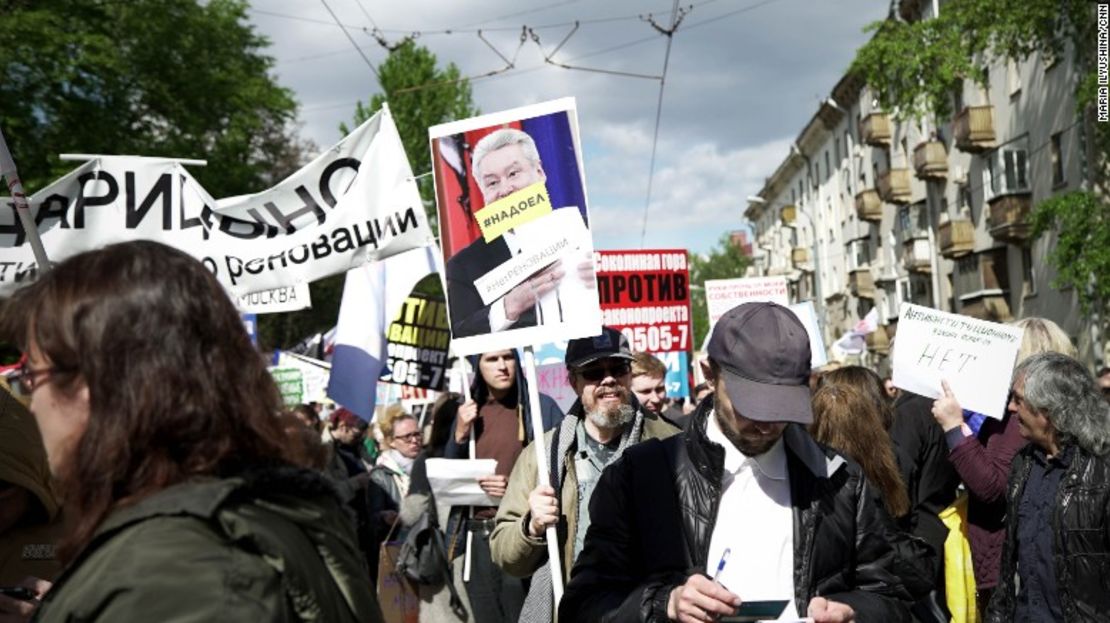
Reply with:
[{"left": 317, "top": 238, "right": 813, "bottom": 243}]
[{"left": 987, "top": 352, "right": 1110, "bottom": 623}]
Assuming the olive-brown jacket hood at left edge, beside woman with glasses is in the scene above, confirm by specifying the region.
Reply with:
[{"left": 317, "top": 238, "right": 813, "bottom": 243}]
[{"left": 0, "top": 386, "right": 59, "bottom": 522}]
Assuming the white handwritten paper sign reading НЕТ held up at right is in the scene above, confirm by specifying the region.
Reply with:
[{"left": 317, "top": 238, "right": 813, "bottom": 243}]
[{"left": 894, "top": 303, "right": 1021, "bottom": 420}]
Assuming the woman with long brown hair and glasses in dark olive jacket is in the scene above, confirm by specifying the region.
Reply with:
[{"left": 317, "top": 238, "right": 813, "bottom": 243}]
[{"left": 6, "top": 241, "right": 381, "bottom": 622}]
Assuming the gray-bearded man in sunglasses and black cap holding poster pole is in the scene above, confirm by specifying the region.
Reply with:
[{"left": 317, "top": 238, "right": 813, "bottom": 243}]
[{"left": 490, "top": 326, "right": 678, "bottom": 623}]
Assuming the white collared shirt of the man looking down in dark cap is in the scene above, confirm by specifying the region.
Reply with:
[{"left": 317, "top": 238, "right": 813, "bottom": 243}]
[{"left": 706, "top": 412, "right": 798, "bottom": 620}]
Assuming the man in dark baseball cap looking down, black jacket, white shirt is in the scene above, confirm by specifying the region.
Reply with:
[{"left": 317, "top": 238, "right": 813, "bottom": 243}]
[{"left": 559, "top": 303, "right": 910, "bottom": 623}]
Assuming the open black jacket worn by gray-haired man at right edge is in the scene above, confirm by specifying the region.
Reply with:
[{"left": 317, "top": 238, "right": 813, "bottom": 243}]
[{"left": 987, "top": 444, "right": 1110, "bottom": 623}]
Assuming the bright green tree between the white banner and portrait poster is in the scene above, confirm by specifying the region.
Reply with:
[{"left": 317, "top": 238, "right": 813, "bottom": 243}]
[{"left": 340, "top": 39, "right": 478, "bottom": 222}]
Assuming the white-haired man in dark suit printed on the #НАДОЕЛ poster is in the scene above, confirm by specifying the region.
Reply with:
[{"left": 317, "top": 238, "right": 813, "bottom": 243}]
[{"left": 446, "top": 128, "right": 596, "bottom": 338}]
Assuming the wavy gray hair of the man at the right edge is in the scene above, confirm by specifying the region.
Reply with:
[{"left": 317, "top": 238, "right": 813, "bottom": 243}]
[{"left": 1013, "top": 352, "right": 1110, "bottom": 456}]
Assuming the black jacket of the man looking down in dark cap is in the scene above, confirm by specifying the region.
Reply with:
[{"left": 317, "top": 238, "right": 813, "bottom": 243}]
[{"left": 558, "top": 400, "right": 910, "bottom": 623}]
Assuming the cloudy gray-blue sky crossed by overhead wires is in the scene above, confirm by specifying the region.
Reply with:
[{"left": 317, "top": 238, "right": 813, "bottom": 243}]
[{"left": 250, "top": 0, "right": 889, "bottom": 252}]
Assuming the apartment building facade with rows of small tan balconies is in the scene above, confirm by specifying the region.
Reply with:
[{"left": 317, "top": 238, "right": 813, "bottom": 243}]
[{"left": 745, "top": 0, "right": 1108, "bottom": 368}]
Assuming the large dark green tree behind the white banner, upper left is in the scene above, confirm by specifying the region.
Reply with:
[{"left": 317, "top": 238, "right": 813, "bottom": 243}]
[{"left": 0, "top": 0, "right": 306, "bottom": 197}]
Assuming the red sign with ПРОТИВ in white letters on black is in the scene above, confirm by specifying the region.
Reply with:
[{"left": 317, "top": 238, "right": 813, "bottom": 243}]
[{"left": 594, "top": 249, "right": 693, "bottom": 396}]
